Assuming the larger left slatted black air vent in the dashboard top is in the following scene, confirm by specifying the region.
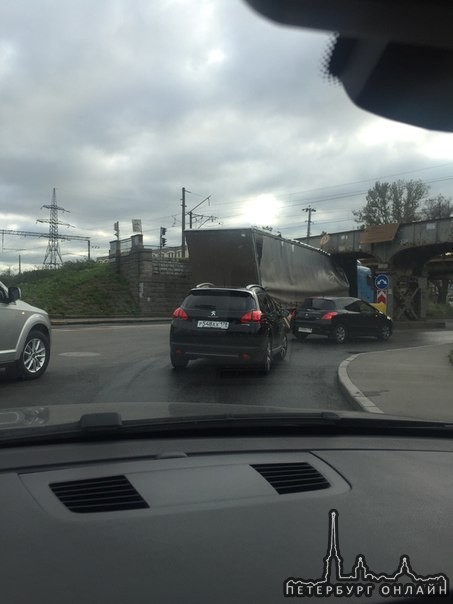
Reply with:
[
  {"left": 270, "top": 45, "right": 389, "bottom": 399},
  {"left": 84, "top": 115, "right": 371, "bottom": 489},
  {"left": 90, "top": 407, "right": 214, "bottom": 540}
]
[{"left": 49, "top": 476, "right": 149, "bottom": 514}]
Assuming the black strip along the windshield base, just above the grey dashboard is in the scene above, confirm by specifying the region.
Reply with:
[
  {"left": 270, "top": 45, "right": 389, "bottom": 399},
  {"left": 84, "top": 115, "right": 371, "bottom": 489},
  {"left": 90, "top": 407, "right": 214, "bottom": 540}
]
[{"left": 0, "top": 411, "right": 453, "bottom": 446}]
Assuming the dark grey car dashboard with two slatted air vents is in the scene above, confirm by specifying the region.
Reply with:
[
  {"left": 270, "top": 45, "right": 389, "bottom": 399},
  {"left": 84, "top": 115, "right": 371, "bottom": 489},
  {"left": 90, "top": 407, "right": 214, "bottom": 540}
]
[{"left": 0, "top": 435, "right": 453, "bottom": 604}]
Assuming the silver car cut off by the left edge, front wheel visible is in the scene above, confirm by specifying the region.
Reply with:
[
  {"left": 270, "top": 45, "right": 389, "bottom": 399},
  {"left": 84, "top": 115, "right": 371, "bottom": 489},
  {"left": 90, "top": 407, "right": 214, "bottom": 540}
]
[{"left": 0, "top": 281, "right": 51, "bottom": 380}]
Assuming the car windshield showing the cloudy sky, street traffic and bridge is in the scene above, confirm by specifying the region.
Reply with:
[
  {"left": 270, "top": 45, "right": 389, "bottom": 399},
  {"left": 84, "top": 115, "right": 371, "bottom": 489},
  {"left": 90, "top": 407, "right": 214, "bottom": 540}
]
[{"left": 0, "top": 0, "right": 453, "bottom": 439}]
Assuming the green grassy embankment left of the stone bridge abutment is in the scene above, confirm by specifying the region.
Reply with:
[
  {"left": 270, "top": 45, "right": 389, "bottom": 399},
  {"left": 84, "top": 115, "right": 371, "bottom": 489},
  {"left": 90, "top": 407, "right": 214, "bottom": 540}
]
[{"left": 0, "top": 262, "right": 139, "bottom": 318}]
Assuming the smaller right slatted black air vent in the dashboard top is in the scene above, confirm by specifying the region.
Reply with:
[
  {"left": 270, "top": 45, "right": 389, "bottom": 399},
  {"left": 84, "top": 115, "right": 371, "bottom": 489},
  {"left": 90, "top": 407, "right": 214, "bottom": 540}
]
[{"left": 252, "top": 462, "right": 330, "bottom": 495}]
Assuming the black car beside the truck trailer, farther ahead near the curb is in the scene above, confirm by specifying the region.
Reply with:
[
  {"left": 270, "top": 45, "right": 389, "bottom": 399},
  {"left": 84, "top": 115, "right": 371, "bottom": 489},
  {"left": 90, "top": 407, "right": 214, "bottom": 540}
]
[{"left": 291, "top": 297, "right": 393, "bottom": 344}]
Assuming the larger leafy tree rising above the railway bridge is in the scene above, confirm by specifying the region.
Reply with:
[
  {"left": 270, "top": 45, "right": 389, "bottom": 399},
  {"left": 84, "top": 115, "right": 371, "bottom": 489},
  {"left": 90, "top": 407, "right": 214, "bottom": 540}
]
[{"left": 352, "top": 180, "right": 429, "bottom": 226}]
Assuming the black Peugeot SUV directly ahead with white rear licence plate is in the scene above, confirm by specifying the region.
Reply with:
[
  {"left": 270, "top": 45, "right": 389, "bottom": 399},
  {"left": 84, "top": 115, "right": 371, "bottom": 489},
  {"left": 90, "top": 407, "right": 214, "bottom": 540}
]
[{"left": 170, "top": 283, "right": 289, "bottom": 373}]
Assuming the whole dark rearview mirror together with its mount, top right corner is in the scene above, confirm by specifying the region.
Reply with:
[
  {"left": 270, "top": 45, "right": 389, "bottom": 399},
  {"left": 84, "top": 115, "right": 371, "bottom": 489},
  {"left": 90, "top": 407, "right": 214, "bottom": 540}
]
[{"left": 245, "top": 0, "right": 453, "bottom": 132}]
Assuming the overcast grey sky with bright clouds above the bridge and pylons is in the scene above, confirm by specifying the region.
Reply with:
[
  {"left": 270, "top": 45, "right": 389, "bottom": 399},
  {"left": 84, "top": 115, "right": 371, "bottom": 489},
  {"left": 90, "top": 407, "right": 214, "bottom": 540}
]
[{"left": 0, "top": 0, "right": 453, "bottom": 271}]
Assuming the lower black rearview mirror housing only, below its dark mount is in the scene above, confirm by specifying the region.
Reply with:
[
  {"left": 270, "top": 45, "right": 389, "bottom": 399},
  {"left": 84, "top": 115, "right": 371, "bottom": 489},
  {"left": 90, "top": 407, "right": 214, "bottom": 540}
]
[{"left": 326, "top": 36, "right": 453, "bottom": 132}]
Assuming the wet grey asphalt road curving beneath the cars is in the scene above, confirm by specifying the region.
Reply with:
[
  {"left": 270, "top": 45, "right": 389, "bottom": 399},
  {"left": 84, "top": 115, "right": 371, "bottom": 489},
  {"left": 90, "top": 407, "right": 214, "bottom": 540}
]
[{"left": 0, "top": 324, "right": 452, "bottom": 409}]
